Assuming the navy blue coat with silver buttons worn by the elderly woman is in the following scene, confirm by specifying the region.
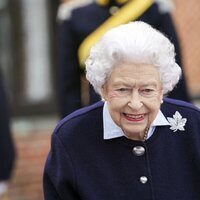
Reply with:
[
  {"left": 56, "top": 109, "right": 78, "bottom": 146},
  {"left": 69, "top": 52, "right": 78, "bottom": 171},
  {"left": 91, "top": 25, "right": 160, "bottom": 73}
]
[{"left": 43, "top": 99, "right": 200, "bottom": 200}]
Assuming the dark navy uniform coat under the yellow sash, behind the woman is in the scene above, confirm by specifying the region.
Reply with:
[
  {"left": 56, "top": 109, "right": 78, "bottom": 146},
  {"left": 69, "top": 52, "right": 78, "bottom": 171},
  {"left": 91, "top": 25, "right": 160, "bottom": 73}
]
[{"left": 57, "top": 1, "right": 190, "bottom": 117}]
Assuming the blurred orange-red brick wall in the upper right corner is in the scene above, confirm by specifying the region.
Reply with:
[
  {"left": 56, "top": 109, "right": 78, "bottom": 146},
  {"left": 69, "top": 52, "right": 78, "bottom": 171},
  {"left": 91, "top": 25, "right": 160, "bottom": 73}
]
[{"left": 173, "top": 0, "right": 200, "bottom": 96}]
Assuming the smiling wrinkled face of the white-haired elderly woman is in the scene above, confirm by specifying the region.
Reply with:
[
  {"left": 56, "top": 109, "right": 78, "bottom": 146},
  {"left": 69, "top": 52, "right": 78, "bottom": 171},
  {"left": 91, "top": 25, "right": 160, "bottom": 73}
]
[{"left": 102, "top": 64, "right": 163, "bottom": 140}]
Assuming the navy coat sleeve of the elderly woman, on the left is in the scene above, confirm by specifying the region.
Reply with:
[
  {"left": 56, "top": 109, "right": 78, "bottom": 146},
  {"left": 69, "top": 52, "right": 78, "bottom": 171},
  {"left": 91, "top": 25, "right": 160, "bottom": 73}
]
[{"left": 43, "top": 134, "right": 80, "bottom": 200}]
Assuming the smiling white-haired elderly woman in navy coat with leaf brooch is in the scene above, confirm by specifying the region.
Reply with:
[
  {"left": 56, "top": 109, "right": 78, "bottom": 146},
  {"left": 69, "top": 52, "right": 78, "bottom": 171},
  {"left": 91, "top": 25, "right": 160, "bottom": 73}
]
[{"left": 44, "top": 22, "right": 200, "bottom": 200}]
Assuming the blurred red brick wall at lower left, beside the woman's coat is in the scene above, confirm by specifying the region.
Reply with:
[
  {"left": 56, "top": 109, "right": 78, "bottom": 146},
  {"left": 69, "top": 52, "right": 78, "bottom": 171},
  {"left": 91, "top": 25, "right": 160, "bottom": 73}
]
[{"left": 9, "top": 130, "right": 51, "bottom": 200}]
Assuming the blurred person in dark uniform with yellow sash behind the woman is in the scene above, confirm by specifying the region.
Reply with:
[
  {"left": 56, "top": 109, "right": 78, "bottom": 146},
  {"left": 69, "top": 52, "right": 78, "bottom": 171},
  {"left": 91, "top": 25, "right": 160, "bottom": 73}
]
[{"left": 57, "top": 0, "right": 190, "bottom": 117}]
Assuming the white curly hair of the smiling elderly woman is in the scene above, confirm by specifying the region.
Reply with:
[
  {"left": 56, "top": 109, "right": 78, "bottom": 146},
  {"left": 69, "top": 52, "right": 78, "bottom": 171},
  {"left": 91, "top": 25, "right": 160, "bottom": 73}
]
[{"left": 85, "top": 21, "right": 181, "bottom": 95}]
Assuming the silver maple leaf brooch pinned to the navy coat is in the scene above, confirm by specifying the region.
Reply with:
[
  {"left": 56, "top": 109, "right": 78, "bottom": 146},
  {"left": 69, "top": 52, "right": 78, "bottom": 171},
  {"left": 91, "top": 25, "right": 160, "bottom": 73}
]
[{"left": 167, "top": 111, "right": 187, "bottom": 132}]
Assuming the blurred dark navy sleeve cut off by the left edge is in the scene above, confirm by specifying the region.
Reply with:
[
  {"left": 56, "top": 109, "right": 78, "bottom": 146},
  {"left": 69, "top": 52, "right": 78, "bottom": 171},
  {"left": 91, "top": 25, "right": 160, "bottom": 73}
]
[{"left": 0, "top": 69, "right": 15, "bottom": 181}]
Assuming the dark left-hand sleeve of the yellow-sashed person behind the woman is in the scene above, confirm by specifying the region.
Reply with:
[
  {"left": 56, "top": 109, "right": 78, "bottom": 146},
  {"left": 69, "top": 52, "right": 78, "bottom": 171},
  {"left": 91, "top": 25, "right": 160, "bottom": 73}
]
[{"left": 57, "top": 19, "right": 81, "bottom": 117}]
